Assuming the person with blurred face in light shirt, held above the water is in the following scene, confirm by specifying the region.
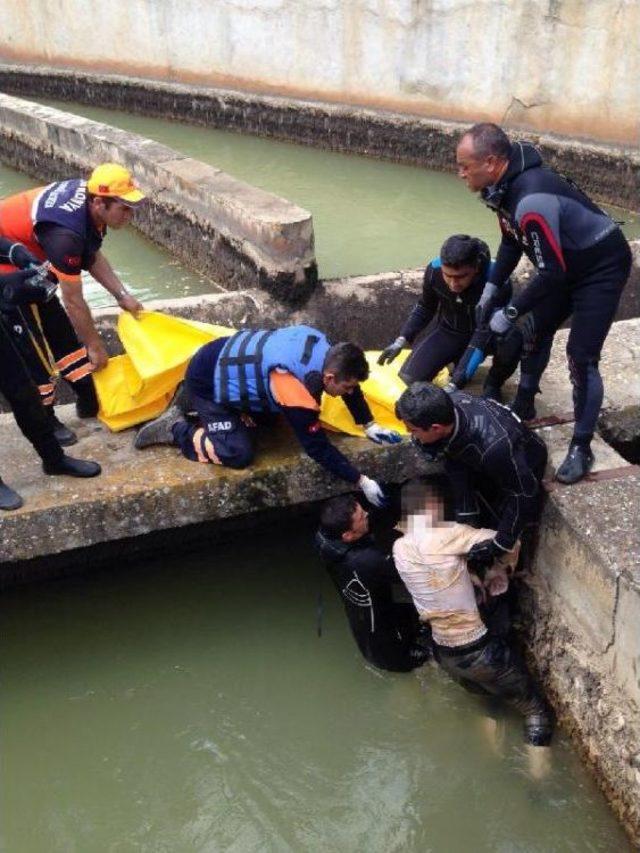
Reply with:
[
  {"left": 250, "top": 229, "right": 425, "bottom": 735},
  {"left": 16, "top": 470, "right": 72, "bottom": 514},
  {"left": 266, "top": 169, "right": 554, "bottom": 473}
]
[{"left": 393, "top": 483, "right": 552, "bottom": 746}]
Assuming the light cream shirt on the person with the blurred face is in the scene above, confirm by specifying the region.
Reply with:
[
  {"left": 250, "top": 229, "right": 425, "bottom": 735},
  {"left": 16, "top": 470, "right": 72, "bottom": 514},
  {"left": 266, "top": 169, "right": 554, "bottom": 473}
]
[{"left": 393, "top": 515, "right": 519, "bottom": 647}]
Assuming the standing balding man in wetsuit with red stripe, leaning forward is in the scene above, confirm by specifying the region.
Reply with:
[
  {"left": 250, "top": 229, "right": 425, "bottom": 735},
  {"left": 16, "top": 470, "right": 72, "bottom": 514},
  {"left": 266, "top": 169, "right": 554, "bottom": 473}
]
[{"left": 456, "top": 123, "right": 631, "bottom": 483}]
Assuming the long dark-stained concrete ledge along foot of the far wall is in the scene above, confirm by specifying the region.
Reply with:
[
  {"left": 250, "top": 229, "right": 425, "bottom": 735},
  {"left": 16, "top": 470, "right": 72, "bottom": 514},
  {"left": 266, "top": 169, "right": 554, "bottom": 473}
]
[{"left": 0, "top": 64, "right": 640, "bottom": 210}]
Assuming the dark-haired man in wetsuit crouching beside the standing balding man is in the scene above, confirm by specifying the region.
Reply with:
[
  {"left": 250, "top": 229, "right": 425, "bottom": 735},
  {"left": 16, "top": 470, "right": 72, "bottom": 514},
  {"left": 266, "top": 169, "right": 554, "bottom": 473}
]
[{"left": 378, "top": 234, "right": 522, "bottom": 400}]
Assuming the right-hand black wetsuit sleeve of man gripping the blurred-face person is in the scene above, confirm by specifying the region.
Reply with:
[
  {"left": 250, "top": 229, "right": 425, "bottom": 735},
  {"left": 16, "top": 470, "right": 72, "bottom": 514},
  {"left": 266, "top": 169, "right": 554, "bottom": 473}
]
[{"left": 482, "top": 438, "right": 540, "bottom": 551}]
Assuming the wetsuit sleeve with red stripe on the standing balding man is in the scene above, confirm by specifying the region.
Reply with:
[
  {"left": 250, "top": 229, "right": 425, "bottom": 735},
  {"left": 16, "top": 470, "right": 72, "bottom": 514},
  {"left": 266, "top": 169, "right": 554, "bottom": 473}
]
[{"left": 513, "top": 193, "right": 567, "bottom": 314}]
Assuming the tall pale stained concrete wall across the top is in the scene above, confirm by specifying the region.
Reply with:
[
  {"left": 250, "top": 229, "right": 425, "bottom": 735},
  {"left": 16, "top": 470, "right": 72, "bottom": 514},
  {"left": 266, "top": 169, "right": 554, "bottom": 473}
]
[{"left": 0, "top": 0, "right": 640, "bottom": 144}]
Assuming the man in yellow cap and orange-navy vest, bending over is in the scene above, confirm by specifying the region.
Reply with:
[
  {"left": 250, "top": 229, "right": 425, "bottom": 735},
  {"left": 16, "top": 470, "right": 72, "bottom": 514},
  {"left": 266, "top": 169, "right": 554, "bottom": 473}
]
[{"left": 0, "top": 163, "right": 144, "bottom": 445}]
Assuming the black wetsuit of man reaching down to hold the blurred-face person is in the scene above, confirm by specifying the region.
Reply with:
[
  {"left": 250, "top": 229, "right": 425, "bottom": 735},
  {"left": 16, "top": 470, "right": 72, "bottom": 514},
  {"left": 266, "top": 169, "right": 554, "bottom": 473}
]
[{"left": 418, "top": 392, "right": 547, "bottom": 551}]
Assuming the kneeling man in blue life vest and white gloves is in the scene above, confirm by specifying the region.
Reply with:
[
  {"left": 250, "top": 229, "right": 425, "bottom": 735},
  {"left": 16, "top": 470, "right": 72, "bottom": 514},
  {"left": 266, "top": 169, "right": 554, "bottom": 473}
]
[{"left": 135, "top": 326, "right": 401, "bottom": 506}]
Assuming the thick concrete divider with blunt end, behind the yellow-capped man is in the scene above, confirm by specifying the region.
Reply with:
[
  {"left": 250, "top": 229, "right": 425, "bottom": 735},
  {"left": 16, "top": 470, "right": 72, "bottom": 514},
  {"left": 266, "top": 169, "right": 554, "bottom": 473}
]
[{"left": 0, "top": 95, "right": 317, "bottom": 302}]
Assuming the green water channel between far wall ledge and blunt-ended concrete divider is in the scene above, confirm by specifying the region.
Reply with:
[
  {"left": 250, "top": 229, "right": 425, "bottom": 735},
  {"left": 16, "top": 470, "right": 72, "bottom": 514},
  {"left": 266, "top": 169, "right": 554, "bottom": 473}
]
[{"left": 33, "top": 101, "right": 640, "bottom": 278}]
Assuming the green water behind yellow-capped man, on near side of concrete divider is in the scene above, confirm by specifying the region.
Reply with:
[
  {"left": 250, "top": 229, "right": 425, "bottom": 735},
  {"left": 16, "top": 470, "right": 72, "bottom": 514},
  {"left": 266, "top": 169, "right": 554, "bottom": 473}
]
[{"left": 0, "top": 164, "right": 215, "bottom": 308}]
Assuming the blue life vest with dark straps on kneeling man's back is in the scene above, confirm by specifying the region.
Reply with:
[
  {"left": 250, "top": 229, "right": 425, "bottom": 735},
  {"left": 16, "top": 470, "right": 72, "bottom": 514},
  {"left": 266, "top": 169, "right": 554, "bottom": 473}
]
[{"left": 213, "top": 326, "right": 331, "bottom": 412}]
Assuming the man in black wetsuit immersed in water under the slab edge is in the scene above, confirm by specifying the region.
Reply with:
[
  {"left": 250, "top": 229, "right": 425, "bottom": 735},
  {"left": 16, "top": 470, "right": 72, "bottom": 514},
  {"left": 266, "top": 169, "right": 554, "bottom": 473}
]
[{"left": 316, "top": 495, "right": 429, "bottom": 672}]
